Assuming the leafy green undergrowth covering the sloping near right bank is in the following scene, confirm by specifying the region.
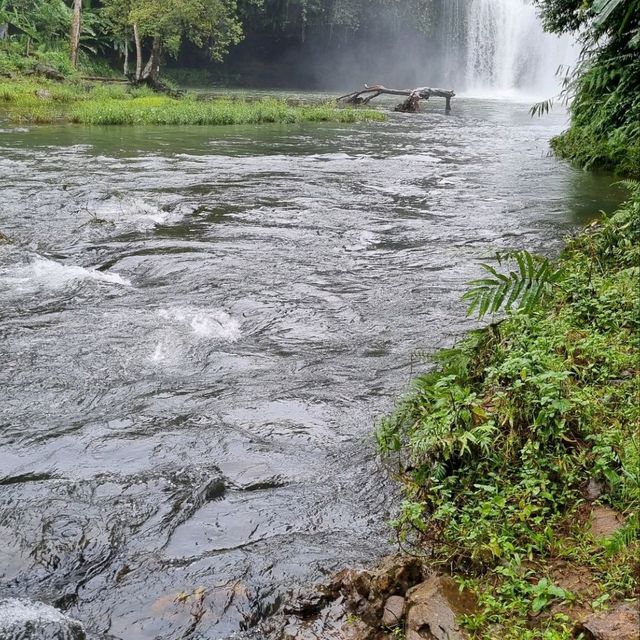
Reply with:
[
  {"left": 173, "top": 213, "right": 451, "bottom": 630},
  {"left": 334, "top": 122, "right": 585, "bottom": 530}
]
[{"left": 377, "top": 183, "right": 640, "bottom": 640}]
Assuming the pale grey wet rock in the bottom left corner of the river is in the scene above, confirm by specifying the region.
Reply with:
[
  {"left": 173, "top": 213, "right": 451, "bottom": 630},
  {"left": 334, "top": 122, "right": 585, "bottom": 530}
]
[{"left": 0, "top": 598, "right": 86, "bottom": 640}]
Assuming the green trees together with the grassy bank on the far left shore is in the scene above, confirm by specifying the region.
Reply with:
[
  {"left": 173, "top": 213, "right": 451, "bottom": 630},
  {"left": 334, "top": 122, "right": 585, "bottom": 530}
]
[{"left": 0, "top": 0, "right": 383, "bottom": 125}]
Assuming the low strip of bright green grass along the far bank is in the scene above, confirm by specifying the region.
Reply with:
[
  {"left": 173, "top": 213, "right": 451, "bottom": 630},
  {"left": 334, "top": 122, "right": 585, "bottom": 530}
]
[{"left": 0, "top": 80, "right": 385, "bottom": 125}]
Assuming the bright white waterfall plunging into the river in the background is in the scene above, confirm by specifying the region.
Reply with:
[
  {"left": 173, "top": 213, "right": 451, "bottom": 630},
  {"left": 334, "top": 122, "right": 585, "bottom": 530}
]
[{"left": 465, "top": 0, "right": 576, "bottom": 96}]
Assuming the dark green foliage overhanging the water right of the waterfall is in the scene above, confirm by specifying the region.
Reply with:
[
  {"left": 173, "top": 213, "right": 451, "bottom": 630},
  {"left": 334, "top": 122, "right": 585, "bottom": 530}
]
[{"left": 538, "top": 0, "right": 640, "bottom": 176}]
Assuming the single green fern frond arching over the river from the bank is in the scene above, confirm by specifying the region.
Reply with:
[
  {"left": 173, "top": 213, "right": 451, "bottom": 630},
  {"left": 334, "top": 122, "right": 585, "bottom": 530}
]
[{"left": 462, "top": 250, "right": 563, "bottom": 319}]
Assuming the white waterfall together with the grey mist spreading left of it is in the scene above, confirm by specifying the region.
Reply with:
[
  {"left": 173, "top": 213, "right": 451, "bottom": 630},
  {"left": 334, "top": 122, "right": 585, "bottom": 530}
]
[{"left": 220, "top": 0, "right": 577, "bottom": 100}]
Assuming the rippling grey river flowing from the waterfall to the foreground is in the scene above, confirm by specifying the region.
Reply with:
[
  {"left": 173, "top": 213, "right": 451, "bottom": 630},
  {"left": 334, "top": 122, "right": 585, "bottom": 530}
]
[{"left": 0, "top": 100, "right": 617, "bottom": 640}]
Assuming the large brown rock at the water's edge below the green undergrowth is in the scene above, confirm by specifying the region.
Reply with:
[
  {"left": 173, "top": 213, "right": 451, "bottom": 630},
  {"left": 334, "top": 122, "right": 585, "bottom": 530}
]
[{"left": 407, "top": 576, "right": 476, "bottom": 640}]
